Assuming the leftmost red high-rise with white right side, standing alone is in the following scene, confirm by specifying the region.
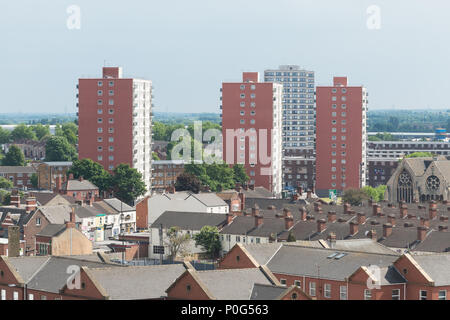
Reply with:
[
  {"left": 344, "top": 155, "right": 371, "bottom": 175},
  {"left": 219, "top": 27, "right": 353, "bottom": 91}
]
[{"left": 77, "top": 67, "right": 152, "bottom": 190}]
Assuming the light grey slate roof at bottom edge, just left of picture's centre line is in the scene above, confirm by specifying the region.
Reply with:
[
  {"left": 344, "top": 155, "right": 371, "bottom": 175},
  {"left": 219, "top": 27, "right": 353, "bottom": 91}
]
[{"left": 196, "top": 268, "right": 271, "bottom": 300}]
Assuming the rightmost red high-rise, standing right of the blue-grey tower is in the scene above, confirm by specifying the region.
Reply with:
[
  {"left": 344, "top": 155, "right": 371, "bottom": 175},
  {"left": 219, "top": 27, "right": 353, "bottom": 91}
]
[{"left": 316, "top": 77, "right": 368, "bottom": 196}]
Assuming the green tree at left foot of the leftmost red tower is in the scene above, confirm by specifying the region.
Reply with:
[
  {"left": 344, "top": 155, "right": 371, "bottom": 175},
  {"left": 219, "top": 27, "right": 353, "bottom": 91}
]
[{"left": 67, "top": 159, "right": 111, "bottom": 192}]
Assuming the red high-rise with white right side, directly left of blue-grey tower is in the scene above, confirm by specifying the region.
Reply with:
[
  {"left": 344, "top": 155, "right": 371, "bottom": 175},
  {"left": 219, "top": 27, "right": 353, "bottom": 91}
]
[{"left": 221, "top": 72, "right": 283, "bottom": 196}]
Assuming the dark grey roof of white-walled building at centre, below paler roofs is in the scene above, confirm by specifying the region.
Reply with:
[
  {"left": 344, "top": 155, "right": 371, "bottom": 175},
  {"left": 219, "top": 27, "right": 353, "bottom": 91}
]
[{"left": 151, "top": 211, "right": 227, "bottom": 230}]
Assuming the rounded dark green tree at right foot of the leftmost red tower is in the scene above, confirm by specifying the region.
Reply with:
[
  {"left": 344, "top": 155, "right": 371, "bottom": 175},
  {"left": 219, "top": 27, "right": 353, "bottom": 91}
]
[{"left": 111, "top": 163, "right": 147, "bottom": 205}]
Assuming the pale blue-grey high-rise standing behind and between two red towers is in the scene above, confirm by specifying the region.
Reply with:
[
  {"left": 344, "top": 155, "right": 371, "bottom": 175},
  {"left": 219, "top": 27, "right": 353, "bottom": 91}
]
[{"left": 264, "top": 65, "right": 316, "bottom": 190}]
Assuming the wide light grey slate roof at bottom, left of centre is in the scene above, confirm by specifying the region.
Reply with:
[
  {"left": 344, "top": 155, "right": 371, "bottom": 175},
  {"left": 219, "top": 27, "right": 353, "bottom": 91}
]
[{"left": 89, "top": 264, "right": 186, "bottom": 300}]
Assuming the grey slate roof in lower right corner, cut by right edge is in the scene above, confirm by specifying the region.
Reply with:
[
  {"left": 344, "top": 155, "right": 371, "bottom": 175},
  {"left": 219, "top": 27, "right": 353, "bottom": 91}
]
[{"left": 413, "top": 253, "right": 450, "bottom": 286}]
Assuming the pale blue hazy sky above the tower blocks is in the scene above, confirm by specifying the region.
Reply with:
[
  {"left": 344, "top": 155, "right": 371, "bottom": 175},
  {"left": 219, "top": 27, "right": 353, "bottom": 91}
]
[{"left": 0, "top": 0, "right": 450, "bottom": 113}]
